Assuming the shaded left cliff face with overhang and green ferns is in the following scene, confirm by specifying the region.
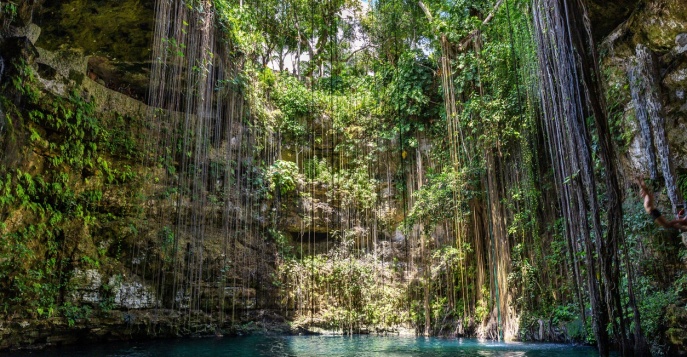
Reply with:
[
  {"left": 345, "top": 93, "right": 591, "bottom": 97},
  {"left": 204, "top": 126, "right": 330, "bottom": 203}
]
[{"left": 0, "top": 1, "right": 284, "bottom": 350}]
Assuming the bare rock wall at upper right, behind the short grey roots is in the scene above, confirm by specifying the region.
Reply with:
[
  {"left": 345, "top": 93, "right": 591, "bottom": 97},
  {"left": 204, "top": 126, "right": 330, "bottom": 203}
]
[{"left": 600, "top": 0, "right": 687, "bottom": 175}]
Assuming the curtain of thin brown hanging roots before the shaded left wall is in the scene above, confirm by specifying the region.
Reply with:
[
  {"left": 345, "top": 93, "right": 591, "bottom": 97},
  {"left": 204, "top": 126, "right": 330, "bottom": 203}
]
[{"left": 146, "top": 0, "right": 265, "bottom": 327}]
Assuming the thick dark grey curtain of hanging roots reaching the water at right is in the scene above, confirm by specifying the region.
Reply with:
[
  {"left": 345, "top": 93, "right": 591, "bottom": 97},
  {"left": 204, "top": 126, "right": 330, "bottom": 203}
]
[{"left": 532, "top": 0, "right": 643, "bottom": 355}]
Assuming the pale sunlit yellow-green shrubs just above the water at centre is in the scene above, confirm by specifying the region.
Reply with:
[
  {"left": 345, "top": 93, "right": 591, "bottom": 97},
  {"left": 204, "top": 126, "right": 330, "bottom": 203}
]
[{"left": 277, "top": 241, "right": 408, "bottom": 333}]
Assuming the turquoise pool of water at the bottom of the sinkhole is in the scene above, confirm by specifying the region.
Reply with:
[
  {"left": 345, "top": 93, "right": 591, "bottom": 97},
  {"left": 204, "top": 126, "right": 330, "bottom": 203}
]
[{"left": 10, "top": 335, "right": 598, "bottom": 357}]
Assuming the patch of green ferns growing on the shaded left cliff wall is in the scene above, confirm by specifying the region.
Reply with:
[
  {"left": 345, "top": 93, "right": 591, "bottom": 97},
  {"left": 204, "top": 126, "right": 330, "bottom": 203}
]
[{"left": 0, "top": 62, "right": 140, "bottom": 318}]
